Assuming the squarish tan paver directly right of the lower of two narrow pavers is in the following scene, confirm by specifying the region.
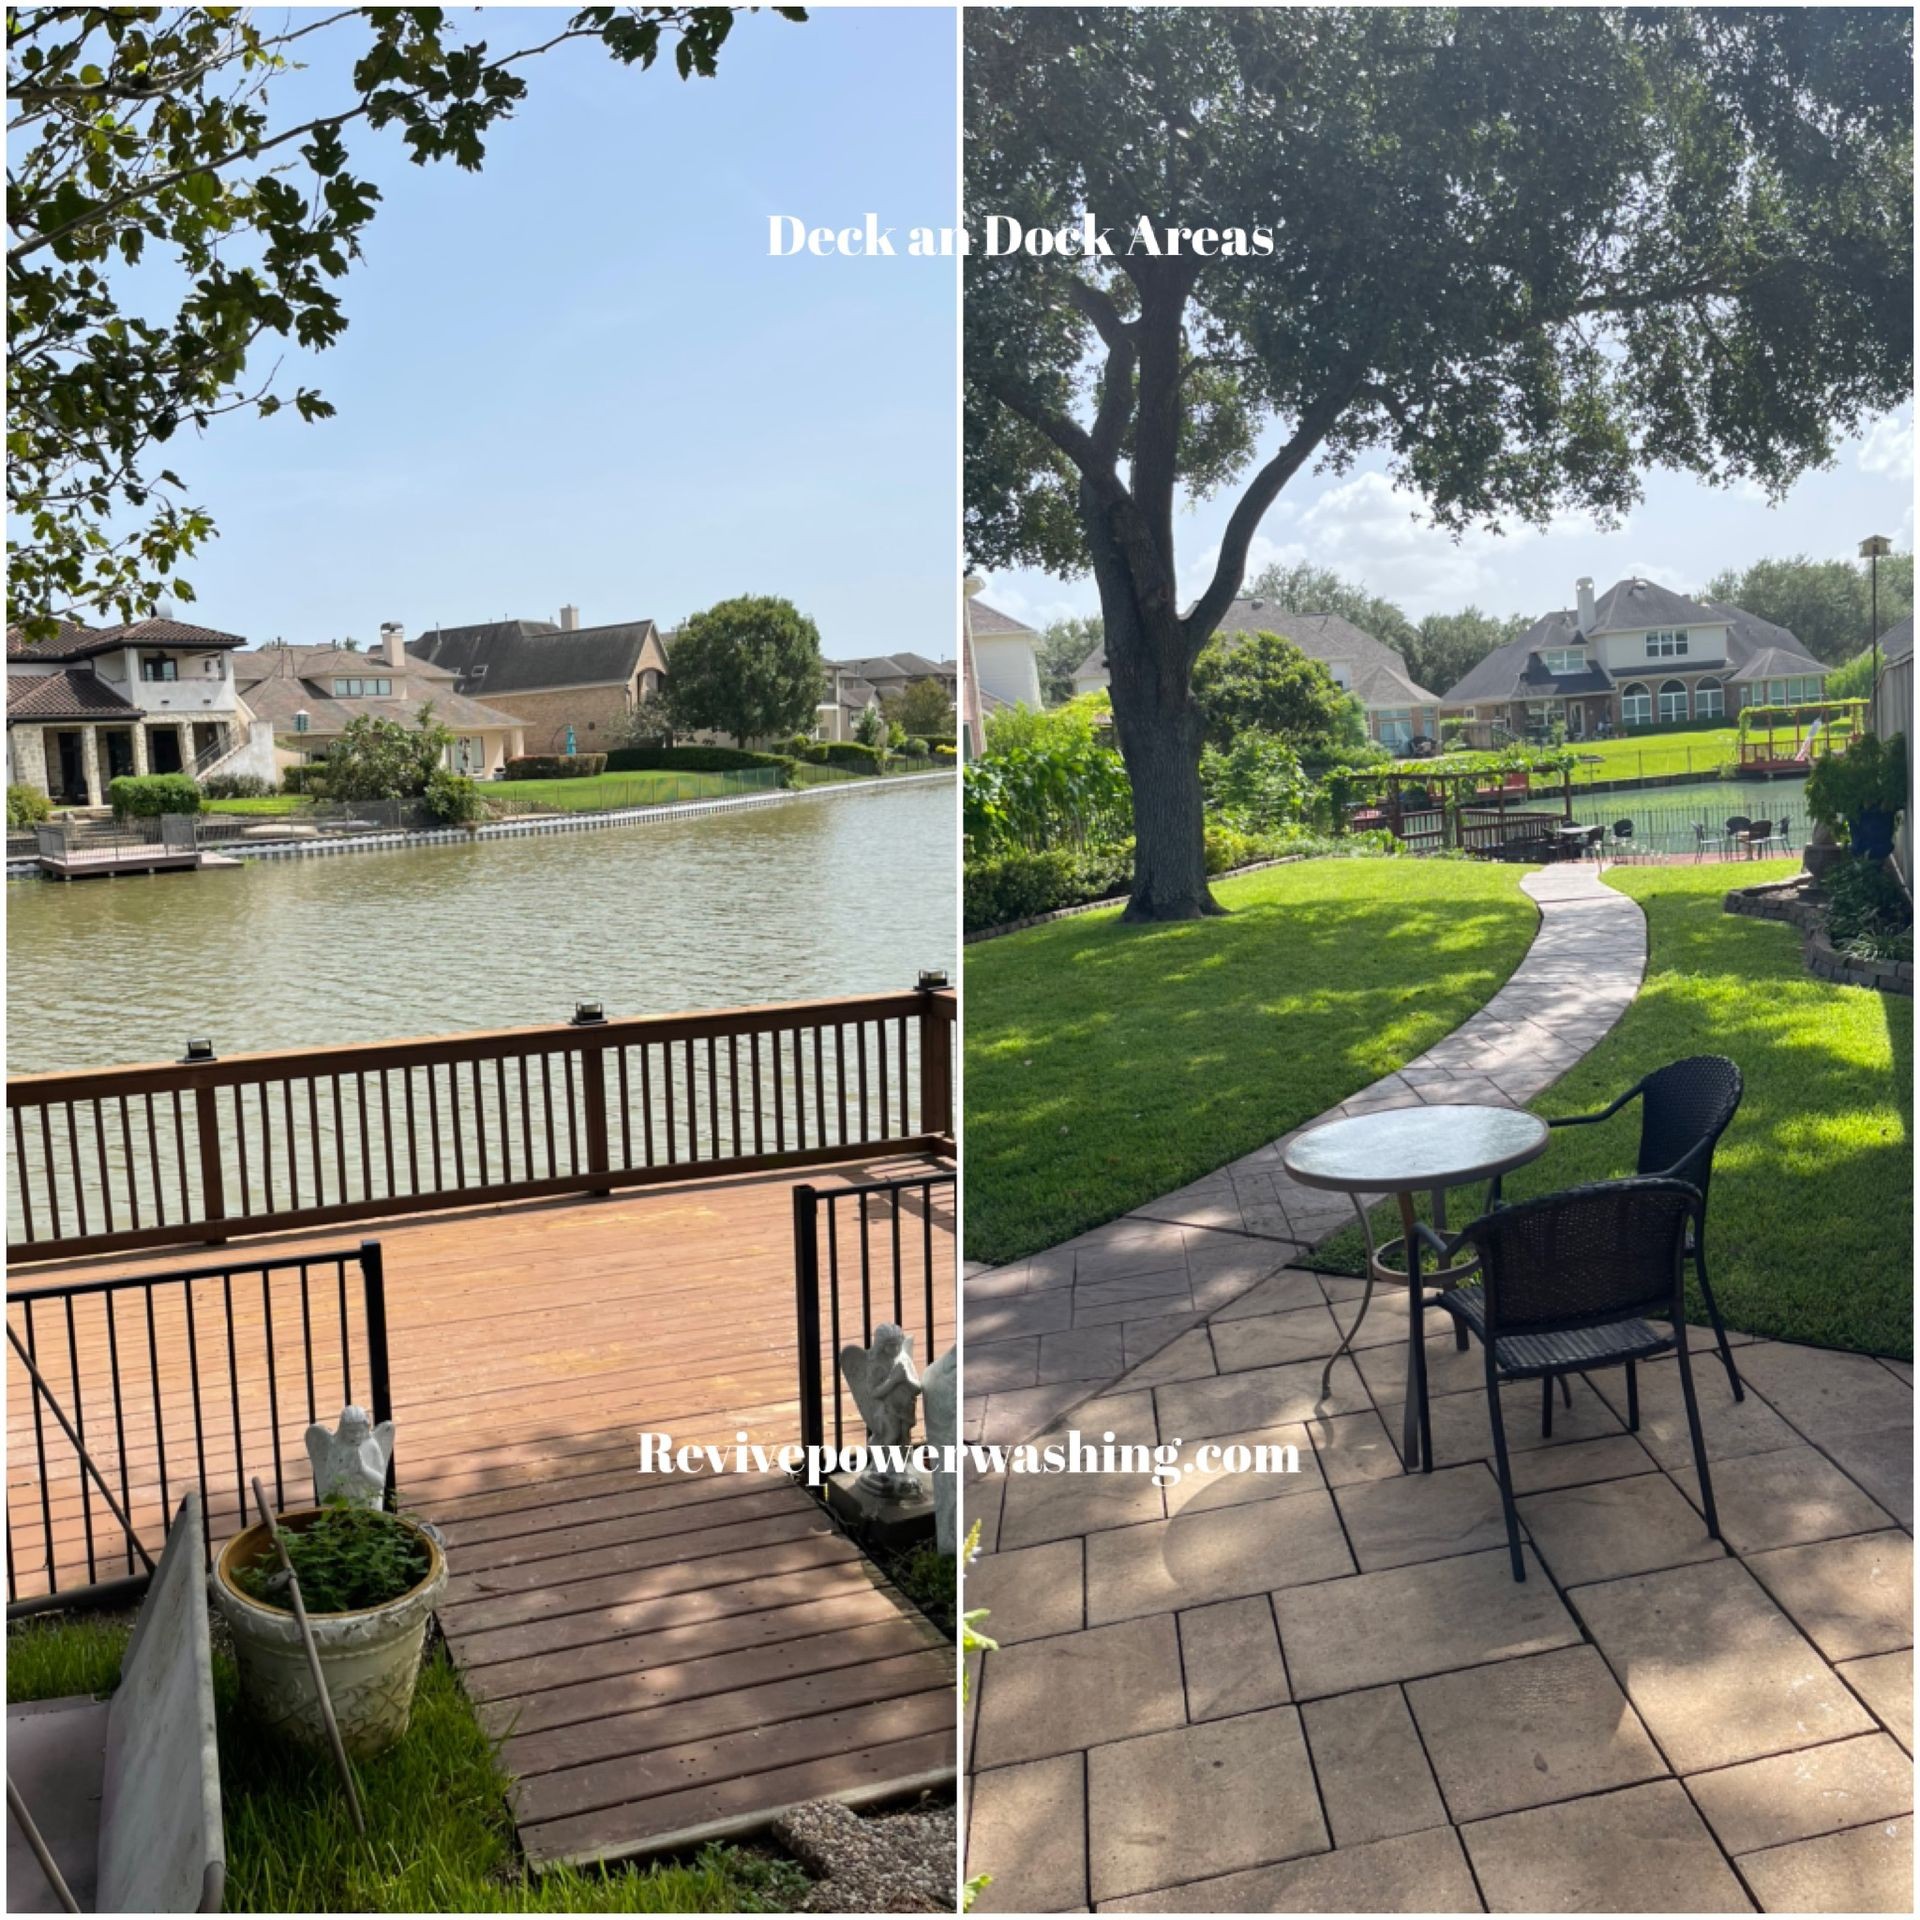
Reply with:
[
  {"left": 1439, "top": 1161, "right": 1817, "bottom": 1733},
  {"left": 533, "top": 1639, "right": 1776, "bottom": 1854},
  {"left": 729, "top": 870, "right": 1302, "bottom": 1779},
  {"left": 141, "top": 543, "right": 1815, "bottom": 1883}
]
[{"left": 1407, "top": 1647, "right": 1667, "bottom": 1824}]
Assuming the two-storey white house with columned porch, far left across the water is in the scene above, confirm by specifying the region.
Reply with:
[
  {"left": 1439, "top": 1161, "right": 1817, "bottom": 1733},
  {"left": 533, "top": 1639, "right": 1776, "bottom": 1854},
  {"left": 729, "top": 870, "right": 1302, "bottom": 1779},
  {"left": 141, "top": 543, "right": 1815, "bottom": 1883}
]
[{"left": 6, "top": 618, "right": 275, "bottom": 806}]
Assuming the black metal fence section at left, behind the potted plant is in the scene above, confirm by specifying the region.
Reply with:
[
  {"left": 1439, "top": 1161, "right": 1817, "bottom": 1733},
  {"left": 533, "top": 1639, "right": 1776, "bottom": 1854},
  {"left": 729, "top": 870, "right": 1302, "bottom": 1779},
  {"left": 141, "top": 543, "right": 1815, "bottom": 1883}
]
[{"left": 6, "top": 1240, "right": 394, "bottom": 1619}]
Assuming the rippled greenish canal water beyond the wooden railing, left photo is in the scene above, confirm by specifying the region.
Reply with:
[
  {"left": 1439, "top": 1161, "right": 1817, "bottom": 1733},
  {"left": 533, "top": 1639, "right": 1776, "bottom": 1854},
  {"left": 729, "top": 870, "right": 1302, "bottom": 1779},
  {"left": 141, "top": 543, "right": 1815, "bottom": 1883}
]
[{"left": 6, "top": 781, "right": 958, "bottom": 1073}]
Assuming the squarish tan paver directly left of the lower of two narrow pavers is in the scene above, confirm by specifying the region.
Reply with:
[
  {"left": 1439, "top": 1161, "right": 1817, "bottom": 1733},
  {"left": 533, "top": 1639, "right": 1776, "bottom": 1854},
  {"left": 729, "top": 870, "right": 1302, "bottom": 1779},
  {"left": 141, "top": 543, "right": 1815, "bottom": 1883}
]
[{"left": 1087, "top": 1707, "right": 1331, "bottom": 1903}]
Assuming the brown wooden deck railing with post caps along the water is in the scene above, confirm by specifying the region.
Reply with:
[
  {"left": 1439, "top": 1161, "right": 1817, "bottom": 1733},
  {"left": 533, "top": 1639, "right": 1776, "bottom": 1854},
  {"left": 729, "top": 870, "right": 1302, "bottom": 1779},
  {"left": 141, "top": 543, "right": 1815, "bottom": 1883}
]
[{"left": 8, "top": 987, "right": 954, "bottom": 1261}]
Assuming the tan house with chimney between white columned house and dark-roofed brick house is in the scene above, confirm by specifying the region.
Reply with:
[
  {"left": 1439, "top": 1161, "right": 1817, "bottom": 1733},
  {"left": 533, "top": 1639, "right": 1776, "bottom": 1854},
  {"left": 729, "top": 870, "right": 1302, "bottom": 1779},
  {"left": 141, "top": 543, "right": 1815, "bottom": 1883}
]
[{"left": 234, "top": 624, "right": 526, "bottom": 780}]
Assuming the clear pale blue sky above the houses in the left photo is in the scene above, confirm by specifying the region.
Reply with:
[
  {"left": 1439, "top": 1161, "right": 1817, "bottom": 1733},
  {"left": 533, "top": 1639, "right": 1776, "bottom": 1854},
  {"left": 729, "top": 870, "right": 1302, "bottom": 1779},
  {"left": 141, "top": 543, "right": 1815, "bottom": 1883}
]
[{"left": 151, "top": 8, "right": 958, "bottom": 659}]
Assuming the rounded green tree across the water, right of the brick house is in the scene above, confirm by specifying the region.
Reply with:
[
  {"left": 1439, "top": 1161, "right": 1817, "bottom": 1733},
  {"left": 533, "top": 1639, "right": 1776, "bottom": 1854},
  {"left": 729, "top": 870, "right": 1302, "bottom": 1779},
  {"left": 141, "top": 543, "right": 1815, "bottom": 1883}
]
[{"left": 666, "top": 593, "right": 826, "bottom": 747}]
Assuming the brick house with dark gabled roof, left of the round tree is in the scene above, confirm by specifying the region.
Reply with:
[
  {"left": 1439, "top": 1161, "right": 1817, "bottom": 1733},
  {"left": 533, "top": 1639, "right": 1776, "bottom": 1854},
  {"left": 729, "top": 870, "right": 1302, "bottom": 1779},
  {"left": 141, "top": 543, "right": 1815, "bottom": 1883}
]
[{"left": 407, "top": 607, "right": 672, "bottom": 753}]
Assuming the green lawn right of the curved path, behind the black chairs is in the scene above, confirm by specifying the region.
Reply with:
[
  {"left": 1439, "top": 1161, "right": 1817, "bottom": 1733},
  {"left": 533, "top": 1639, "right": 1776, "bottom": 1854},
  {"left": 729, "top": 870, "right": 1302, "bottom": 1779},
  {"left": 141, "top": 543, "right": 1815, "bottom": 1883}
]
[{"left": 1317, "top": 860, "right": 1912, "bottom": 1357}]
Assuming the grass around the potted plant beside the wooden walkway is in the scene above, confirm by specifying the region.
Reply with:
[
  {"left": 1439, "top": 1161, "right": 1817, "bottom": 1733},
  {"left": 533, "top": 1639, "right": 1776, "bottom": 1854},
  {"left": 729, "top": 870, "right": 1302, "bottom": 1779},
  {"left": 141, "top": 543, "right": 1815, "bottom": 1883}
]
[{"left": 6, "top": 1619, "right": 808, "bottom": 1914}]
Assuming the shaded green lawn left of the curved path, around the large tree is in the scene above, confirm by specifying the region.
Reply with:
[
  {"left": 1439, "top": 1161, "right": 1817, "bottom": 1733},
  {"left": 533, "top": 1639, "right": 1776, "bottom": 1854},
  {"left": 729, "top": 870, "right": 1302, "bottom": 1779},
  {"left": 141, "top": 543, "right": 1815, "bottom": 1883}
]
[{"left": 966, "top": 858, "right": 1538, "bottom": 1261}]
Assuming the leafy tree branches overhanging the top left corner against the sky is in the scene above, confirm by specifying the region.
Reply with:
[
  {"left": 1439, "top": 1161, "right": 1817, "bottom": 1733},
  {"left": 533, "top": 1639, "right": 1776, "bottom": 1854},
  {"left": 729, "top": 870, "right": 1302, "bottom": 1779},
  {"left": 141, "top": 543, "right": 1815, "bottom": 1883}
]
[{"left": 8, "top": 6, "right": 804, "bottom": 637}]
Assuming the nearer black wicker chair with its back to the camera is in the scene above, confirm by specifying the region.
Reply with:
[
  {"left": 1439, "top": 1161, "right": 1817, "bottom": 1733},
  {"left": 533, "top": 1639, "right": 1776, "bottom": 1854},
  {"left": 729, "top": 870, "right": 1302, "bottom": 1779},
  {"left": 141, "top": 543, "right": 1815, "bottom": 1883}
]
[{"left": 1419, "top": 1179, "right": 1720, "bottom": 1580}]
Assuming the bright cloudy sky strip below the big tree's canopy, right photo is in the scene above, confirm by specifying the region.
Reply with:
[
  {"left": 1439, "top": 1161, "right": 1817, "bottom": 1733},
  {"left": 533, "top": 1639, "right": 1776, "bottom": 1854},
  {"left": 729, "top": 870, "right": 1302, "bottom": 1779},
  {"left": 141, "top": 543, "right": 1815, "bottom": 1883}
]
[{"left": 983, "top": 405, "right": 1914, "bottom": 626}]
